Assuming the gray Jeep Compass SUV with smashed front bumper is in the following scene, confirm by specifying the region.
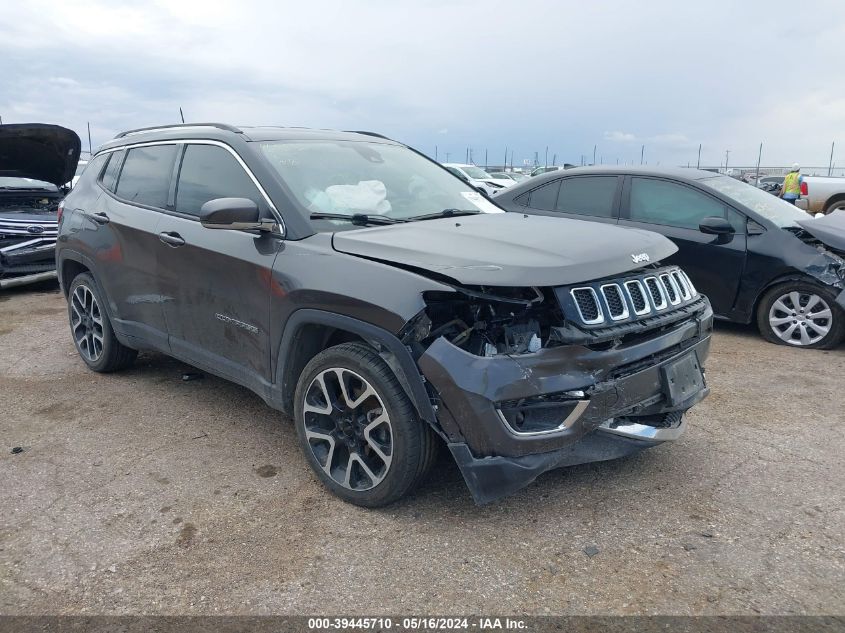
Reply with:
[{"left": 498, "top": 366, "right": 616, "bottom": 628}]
[{"left": 57, "top": 124, "right": 712, "bottom": 506}]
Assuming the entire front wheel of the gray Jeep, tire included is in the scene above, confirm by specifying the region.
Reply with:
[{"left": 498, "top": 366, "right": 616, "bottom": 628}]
[{"left": 294, "top": 343, "right": 436, "bottom": 508}]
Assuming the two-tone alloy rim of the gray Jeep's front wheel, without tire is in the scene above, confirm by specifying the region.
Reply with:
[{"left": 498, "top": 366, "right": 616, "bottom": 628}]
[{"left": 303, "top": 367, "right": 393, "bottom": 491}]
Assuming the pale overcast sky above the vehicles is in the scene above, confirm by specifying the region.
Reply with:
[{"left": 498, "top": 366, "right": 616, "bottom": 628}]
[{"left": 0, "top": 0, "right": 845, "bottom": 166}]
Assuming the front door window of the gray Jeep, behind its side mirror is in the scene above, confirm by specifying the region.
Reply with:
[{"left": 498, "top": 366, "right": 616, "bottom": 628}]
[{"left": 176, "top": 145, "right": 261, "bottom": 215}]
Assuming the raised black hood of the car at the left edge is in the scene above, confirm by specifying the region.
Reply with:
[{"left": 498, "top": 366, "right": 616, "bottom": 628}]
[{"left": 0, "top": 123, "right": 81, "bottom": 187}]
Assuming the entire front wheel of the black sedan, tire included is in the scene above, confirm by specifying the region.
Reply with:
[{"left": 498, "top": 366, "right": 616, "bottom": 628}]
[{"left": 757, "top": 281, "right": 845, "bottom": 349}]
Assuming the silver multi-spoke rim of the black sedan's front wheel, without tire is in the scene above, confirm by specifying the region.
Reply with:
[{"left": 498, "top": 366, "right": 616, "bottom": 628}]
[{"left": 769, "top": 290, "right": 833, "bottom": 346}]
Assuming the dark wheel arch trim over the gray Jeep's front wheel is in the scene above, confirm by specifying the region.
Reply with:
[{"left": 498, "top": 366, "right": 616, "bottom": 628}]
[{"left": 274, "top": 308, "right": 439, "bottom": 430}]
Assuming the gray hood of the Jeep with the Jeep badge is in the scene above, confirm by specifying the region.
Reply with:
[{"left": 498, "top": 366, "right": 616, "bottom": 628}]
[{"left": 333, "top": 213, "right": 678, "bottom": 286}]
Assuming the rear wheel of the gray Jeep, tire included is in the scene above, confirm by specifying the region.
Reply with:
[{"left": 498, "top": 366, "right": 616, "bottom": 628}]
[{"left": 67, "top": 273, "right": 138, "bottom": 373}]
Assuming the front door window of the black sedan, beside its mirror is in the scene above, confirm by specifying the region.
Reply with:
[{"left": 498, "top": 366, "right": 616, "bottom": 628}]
[{"left": 630, "top": 178, "right": 725, "bottom": 229}]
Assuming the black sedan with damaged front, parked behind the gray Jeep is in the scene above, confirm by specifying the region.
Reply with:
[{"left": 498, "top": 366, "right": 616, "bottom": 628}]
[{"left": 494, "top": 167, "right": 845, "bottom": 348}]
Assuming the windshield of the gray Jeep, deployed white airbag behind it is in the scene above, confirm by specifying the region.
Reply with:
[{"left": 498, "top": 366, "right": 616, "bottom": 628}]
[{"left": 260, "top": 141, "right": 503, "bottom": 229}]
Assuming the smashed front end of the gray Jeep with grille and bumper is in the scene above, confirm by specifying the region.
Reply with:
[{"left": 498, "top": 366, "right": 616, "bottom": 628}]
[{"left": 401, "top": 266, "right": 713, "bottom": 503}]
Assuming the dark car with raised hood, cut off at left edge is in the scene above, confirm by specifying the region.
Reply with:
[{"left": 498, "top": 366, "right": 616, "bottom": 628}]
[{"left": 0, "top": 123, "right": 80, "bottom": 288}]
